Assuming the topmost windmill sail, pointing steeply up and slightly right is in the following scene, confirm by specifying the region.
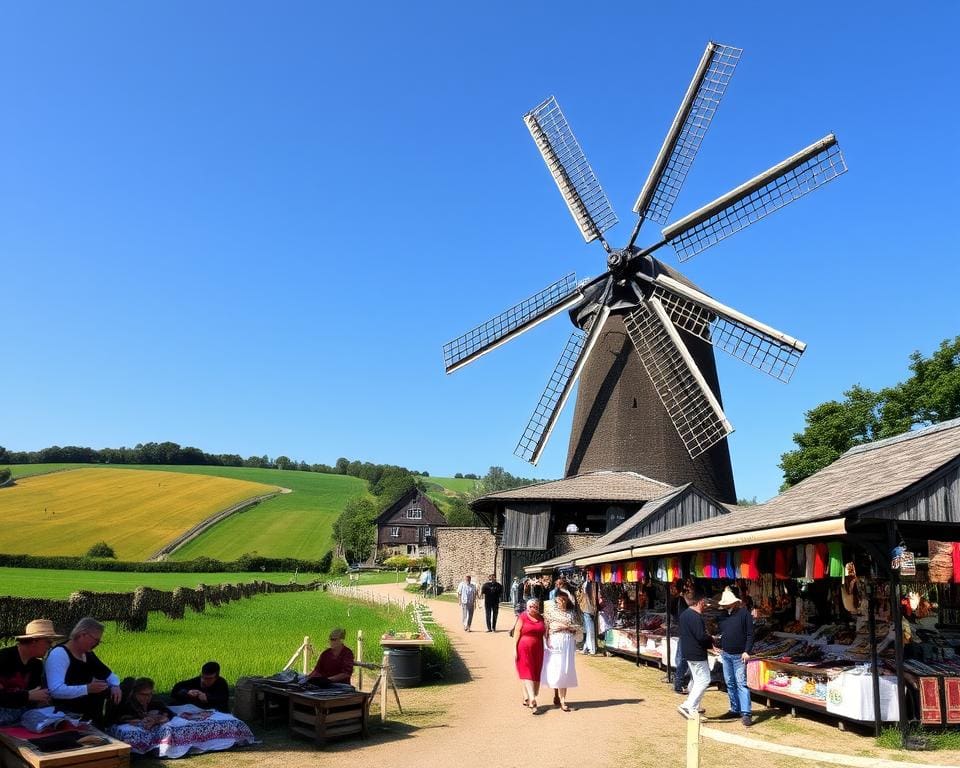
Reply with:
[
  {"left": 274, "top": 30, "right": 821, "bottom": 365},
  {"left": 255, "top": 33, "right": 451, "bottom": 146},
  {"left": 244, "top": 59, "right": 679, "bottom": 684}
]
[{"left": 633, "top": 43, "right": 743, "bottom": 224}]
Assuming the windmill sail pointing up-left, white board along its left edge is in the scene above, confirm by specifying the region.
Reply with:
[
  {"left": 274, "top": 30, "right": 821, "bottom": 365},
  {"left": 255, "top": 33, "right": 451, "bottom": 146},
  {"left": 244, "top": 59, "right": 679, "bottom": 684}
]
[{"left": 523, "top": 96, "right": 618, "bottom": 243}]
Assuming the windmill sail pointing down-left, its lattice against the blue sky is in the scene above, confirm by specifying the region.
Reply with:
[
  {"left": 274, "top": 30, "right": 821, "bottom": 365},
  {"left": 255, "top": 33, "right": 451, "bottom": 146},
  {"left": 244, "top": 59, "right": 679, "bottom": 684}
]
[{"left": 514, "top": 307, "right": 610, "bottom": 464}]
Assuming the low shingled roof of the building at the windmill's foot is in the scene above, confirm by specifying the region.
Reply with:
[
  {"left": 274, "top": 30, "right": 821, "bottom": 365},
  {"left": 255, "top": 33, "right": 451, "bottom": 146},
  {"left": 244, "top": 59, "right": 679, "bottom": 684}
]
[{"left": 470, "top": 464, "right": 674, "bottom": 511}]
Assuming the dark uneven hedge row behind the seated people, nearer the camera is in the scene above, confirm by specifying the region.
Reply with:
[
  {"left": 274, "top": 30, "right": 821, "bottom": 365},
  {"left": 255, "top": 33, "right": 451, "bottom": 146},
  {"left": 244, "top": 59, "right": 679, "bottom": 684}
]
[{"left": 0, "top": 581, "right": 316, "bottom": 638}]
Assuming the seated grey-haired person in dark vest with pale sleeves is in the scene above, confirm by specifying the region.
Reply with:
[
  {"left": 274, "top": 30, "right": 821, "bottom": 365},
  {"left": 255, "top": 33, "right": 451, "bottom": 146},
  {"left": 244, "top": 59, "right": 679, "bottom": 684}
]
[{"left": 44, "top": 616, "right": 121, "bottom": 725}]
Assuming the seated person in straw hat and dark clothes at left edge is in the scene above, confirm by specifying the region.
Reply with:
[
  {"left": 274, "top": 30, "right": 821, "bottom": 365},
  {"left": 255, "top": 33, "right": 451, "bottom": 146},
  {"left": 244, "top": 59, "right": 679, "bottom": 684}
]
[{"left": 0, "top": 619, "right": 63, "bottom": 725}]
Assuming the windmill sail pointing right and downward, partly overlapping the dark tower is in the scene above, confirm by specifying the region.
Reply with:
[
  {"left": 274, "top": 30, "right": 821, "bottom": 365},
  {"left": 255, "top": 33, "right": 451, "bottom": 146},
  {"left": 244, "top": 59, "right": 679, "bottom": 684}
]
[{"left": 653, "top": 275, "right": 807, "bottom": 383}]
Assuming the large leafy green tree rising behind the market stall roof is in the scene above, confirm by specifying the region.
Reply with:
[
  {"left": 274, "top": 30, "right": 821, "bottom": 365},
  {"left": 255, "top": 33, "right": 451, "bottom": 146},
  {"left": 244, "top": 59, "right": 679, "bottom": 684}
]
[{"left": 780, "top": 336, "right": 960, "bottom": 490}]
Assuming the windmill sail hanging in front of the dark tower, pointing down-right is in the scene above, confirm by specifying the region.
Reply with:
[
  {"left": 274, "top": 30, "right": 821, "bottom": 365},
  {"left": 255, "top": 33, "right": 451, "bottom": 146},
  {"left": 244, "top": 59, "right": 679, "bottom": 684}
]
[{"left": 624, "top": 299, "right": 733, "bottom": 458}]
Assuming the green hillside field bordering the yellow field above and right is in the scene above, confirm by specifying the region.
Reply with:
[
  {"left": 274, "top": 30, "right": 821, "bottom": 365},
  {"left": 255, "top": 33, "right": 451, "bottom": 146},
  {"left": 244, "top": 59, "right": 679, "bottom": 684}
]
[{"left": 0, "top": 464, "right": 367, "bottom": 560}]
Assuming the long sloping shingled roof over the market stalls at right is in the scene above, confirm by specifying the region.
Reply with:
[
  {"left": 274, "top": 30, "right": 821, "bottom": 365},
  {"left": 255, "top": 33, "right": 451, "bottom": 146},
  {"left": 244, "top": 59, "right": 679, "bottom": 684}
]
[{"left": 560, "top": 419, "right": 960, "bottom": 561}]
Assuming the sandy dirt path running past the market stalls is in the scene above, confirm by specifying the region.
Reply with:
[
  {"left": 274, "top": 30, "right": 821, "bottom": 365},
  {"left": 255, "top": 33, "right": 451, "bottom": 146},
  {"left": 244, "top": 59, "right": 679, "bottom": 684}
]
[{"left": 139, "top": 584, "right": 960, "bottom": 768}]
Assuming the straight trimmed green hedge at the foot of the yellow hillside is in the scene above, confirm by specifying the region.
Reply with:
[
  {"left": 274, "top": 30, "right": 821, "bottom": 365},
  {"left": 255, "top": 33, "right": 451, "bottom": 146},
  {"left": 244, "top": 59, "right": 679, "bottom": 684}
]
[{"left": 0, "top": 554, "right": 331, "bottom": 573}]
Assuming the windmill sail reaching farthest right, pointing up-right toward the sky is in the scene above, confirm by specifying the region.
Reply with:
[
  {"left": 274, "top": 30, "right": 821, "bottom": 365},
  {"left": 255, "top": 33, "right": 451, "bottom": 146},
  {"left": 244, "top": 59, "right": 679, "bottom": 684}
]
[{"left": 663, "top": 134, "right": 847, "bottom": 261}]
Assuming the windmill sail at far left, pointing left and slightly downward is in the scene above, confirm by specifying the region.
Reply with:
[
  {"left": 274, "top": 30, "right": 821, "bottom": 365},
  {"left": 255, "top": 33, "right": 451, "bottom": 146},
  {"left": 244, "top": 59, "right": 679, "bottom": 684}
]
[{"left": 443, "top": 272, "right": 581, "bottom": 373}]
